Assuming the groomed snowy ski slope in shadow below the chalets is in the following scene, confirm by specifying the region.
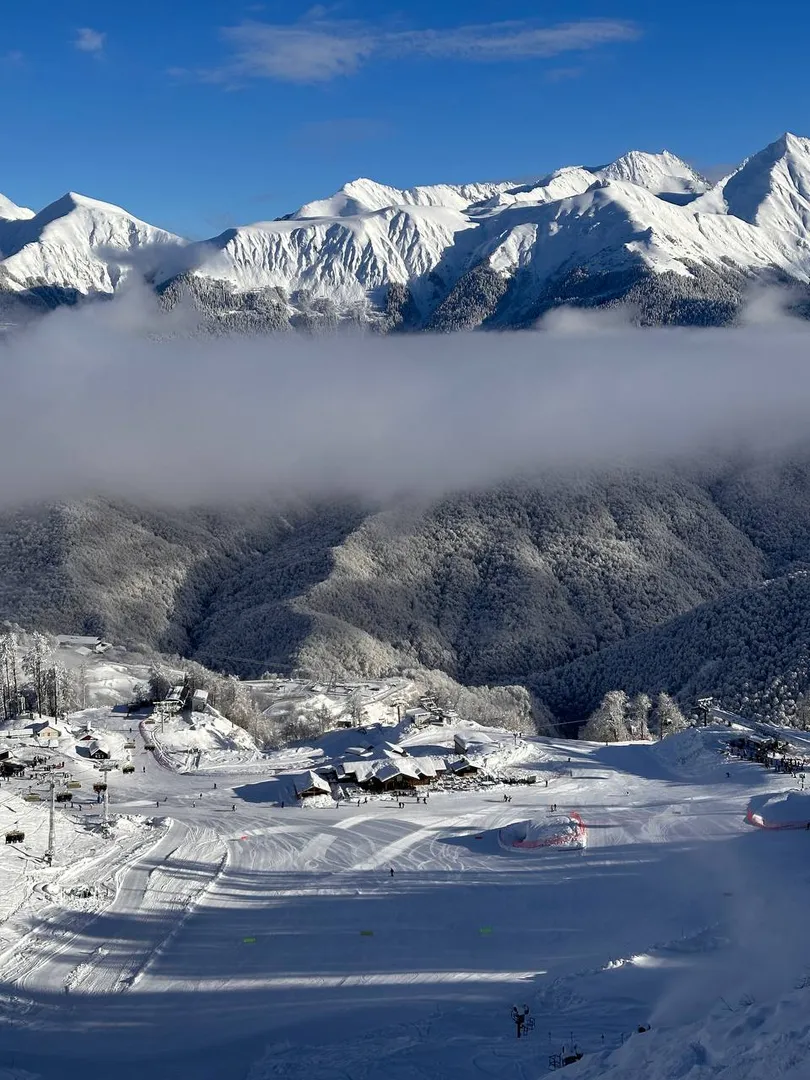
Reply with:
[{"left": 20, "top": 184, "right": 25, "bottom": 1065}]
[{"left": 0, "top": 716, "right": 810, "bottom": 1080}]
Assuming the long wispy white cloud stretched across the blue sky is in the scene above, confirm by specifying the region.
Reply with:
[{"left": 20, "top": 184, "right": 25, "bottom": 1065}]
[{"left": 206, "top": 16, "right": 640, "bottom": 84}]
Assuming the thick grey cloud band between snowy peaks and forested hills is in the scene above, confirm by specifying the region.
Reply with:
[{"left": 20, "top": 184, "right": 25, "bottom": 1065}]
[{"left": 0, "top": 293, "right": 810, "bottom": 505}]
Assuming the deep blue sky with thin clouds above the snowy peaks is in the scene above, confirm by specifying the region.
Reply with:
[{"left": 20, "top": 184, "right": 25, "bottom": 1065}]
[{"left": 0, "top": 0, "right": 810, "bottom": 237}]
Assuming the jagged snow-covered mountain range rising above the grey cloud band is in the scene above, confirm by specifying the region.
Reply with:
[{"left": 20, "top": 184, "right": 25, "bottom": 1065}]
[{"left": 0, "top": 134, "right": 810, "bottom": 329}]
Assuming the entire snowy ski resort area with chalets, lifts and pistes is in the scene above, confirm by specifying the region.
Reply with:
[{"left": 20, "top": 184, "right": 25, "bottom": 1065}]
[{"left": 0, "top": 634, "right": 810, "bottom": 1080}]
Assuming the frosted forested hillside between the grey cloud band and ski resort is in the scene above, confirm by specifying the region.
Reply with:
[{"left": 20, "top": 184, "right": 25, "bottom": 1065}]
[{"left": 0, "top": 462, "right": 810, "bottom": 718}]
